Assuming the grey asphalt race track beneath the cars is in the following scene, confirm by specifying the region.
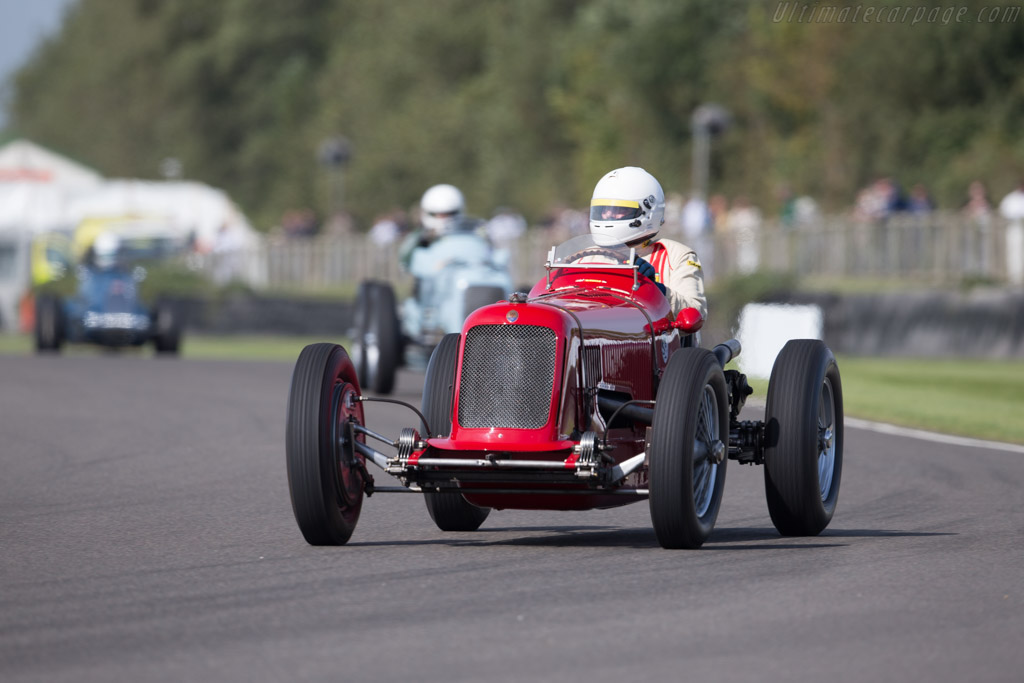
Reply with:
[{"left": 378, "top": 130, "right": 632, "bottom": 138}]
[{"left": 0, "top": 355, "right": 1024, "bottom": 683}]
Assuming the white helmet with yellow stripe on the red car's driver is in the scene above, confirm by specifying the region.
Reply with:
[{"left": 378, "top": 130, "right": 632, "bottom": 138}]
[{"left": 590, "top": 166, "right": 665, "bottom": 247}]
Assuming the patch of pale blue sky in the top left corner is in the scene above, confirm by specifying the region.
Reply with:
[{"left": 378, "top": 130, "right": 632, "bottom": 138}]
[{"left": 0, "top": 0, "right": 77, "bottom": 129}]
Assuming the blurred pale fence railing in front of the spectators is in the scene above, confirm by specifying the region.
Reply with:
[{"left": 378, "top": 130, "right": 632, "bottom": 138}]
[{"left": 204, "top": 212, "right": 1024, "bottom": 291}]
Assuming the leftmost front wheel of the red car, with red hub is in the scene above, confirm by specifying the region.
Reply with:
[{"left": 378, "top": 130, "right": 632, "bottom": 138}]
[{"left": 285, "top": 344, "right": 366, "bottom": 546}]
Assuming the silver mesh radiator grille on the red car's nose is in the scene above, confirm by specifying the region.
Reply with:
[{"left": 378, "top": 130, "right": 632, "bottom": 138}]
[{"left": 459, "top": 325, "right": 555, "bottom": 429}]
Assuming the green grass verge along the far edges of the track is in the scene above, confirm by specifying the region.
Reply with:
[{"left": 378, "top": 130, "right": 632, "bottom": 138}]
[{"left": 0, "top": 335, "right": 1024, "bottom": 443}]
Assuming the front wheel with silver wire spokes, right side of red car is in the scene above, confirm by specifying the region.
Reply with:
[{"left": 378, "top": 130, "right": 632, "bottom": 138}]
[{"left": 648, "top": 348, "right": 729, "bottom": 548}]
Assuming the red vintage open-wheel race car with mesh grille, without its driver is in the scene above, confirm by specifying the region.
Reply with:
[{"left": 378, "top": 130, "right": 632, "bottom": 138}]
[{"left": 286, "top": 236, "right": 843, "bottom": 548}]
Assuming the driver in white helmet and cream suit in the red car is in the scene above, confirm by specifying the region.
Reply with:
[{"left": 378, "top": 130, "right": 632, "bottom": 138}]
[{"left": 590, "top": 166, "right": 708, "bottom": 318}]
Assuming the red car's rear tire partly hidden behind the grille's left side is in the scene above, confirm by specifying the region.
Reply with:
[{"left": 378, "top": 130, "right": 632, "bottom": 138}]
[{"left": 423, "top": 334, "right": 490, "bottom": 531}]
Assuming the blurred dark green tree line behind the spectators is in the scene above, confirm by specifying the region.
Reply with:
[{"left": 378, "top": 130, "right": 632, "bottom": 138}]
[{"left": 7, "top": 0, "right": 1024, "bottom": 227}]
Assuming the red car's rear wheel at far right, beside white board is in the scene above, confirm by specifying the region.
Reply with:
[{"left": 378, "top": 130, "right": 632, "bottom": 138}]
[{"left": 765, "top": 339, "right": 843, "bottom": 536}]
